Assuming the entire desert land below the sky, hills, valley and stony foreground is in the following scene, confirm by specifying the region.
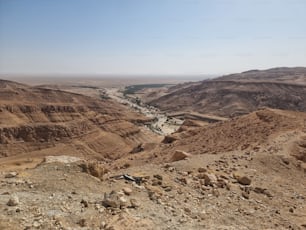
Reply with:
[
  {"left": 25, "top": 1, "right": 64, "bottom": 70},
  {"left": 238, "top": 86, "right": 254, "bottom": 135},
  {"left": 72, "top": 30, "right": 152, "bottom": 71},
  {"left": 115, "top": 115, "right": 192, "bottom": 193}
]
[{"left": 0, "top": 67, "right": 306, "bottom": 230}]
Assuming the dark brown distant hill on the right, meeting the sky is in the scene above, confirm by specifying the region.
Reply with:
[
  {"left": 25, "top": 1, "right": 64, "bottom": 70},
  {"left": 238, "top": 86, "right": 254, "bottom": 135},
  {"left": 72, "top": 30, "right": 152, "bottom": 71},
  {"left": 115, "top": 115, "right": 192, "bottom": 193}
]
[{"left": 150, "top": 68, "right": 306, "bottom": 117}]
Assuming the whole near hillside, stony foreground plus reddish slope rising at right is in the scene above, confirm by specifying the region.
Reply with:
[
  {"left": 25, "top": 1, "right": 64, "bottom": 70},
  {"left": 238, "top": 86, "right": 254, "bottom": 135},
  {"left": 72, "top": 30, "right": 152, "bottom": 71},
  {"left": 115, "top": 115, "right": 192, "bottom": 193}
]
[{"left": 0, "top": 109, "right": 306, "bottom": 230}]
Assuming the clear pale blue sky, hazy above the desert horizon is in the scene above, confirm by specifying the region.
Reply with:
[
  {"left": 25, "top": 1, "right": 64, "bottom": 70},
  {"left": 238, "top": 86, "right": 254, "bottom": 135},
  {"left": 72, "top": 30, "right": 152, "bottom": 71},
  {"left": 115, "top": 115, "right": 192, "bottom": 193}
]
[{"left": 0, "top": 0, "right": 306, "bottom": 76}]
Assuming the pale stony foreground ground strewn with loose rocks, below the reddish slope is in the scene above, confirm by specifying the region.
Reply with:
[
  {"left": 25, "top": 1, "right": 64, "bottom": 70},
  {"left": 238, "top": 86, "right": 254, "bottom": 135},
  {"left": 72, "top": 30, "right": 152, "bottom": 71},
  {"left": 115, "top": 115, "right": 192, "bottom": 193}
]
[{"left": 0, "top": 148, "right": 306, "bottom": 230}]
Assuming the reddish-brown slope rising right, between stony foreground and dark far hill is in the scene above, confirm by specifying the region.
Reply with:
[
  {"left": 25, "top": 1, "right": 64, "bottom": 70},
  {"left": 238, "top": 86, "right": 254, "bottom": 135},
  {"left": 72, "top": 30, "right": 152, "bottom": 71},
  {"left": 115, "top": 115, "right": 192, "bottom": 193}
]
[{"left": 115, "top": 109, "right": 306, "bottom": 165}]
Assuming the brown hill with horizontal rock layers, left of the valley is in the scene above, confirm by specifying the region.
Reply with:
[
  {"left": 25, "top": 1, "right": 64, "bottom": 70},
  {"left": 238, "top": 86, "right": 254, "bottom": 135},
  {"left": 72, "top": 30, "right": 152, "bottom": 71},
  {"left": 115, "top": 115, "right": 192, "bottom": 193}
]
[{"left": 0, "top": 80, "right": 155, "bottom": 163}]
